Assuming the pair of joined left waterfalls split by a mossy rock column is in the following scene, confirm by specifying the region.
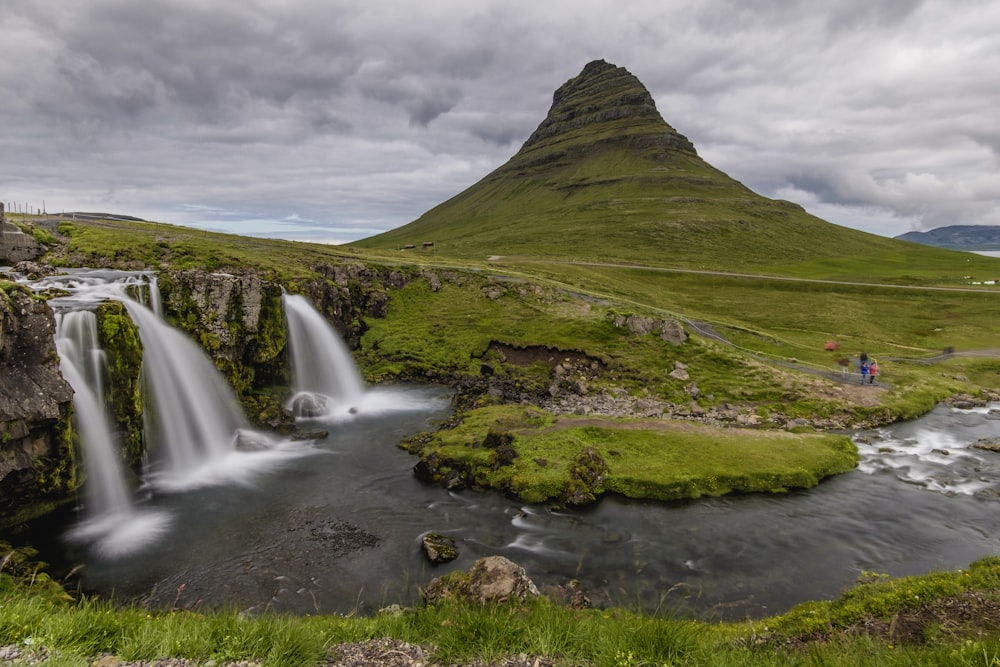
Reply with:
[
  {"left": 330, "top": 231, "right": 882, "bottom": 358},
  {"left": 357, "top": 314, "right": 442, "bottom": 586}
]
[{"left": 32, "top": 270, "right": 317, "bottom": 558}]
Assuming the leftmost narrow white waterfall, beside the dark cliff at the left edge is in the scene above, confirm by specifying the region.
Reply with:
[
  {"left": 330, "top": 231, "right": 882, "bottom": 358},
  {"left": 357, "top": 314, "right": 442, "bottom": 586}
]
[{"left": 56, "top": 310, "right": 170, "bottom": 557}]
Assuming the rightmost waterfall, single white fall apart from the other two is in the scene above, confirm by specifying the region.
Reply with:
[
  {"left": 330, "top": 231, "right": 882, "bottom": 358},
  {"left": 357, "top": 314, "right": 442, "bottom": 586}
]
[{"left": 281, "top": 294, "right": 366, "bottom": 417}]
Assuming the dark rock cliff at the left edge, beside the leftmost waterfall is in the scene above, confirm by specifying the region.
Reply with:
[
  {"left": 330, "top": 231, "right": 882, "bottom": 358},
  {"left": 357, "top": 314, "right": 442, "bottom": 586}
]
[{"left": 0, "top": 283, "right": 78, "bottom": 526}]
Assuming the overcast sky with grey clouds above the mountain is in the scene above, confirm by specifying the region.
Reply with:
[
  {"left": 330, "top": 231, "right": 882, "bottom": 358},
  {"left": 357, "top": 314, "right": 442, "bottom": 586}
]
[{"left": 0, "top": 0, "right": 1000, "bottom": 242}]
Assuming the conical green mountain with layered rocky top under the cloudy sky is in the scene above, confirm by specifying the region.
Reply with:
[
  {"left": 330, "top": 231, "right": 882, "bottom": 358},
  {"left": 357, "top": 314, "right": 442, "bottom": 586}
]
[{"left": 353, "top": 60, "right": 909, "bottom": 269}]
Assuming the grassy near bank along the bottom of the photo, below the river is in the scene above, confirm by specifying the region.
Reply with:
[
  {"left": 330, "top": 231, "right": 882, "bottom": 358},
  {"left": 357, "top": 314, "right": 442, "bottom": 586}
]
[{"left": 0, "top": 558, "right": 1000, "bottom": 667}]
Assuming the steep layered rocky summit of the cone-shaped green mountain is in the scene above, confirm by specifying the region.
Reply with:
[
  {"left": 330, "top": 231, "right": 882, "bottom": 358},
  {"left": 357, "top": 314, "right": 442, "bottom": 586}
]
[{"left": 515, "top": 60, "right": 696, "bottom": 159}]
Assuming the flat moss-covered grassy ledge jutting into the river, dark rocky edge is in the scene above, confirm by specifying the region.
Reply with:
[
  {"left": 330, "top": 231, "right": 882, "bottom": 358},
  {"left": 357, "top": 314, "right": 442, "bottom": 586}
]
[{"left": 401, "top": 405, "right": 858, "bottom": 505}]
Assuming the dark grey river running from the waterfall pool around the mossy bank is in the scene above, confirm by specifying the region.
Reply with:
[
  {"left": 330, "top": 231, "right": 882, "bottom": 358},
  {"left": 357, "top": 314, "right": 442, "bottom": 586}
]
[{"left": 13, "top": 268, "right": 1000, "bottom": 619}]
